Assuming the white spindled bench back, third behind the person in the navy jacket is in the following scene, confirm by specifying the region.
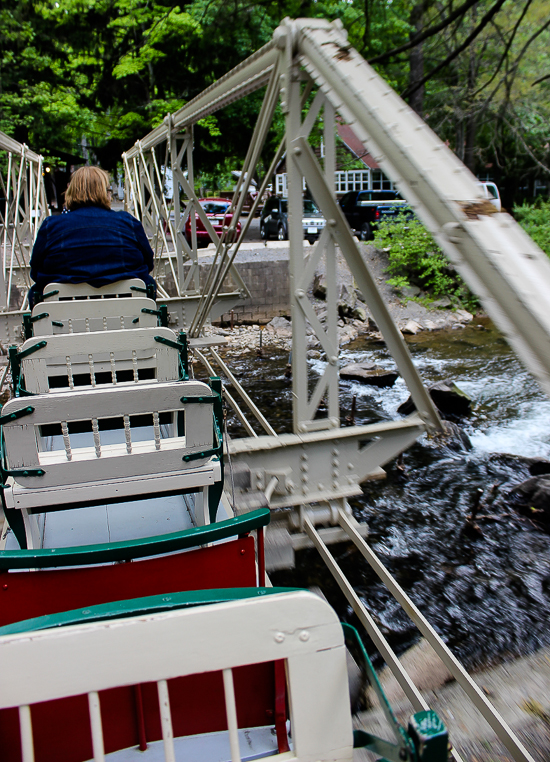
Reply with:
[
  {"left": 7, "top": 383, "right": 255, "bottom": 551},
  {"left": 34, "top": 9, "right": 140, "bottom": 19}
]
[{"left": 10, "top": 326, "right": 182, "bottom": 394}]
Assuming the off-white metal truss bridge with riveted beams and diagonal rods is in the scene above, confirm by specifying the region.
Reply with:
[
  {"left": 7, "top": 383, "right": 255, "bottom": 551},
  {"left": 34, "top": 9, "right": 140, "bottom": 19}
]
[{"left": 0, "top": 19, "right": 550, "bottom": 762}]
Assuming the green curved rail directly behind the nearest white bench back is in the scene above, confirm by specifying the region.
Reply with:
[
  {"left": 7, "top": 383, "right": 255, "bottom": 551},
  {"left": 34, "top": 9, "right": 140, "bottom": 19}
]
[{"left": 0, "top": 587, "right": 299, "bottom": 636}]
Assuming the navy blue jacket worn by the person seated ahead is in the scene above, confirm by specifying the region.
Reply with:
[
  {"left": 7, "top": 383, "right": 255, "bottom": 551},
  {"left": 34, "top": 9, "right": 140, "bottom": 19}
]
[{"left": 30, "top": 206, "right": 155, "bottom": 301}]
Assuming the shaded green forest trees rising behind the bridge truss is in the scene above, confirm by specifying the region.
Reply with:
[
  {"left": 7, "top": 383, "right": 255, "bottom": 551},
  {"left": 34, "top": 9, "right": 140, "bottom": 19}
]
[{"left": 0, "top": 0, "right": 550, "bottom": 208}]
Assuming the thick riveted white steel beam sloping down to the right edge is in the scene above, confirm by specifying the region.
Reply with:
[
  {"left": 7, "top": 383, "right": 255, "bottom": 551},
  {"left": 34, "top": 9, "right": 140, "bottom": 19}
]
[{"left": 286, "top": 19, "right": 550, "bottom": 393}]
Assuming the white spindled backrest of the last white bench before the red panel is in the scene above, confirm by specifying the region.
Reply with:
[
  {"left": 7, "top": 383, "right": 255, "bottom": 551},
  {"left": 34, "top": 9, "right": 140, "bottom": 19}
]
[{"left": 2, "top": 381, "right": 218, "bottom": 490}]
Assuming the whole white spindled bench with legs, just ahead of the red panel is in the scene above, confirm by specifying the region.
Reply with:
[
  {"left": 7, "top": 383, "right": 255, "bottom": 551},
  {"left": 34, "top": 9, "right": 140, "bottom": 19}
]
[{"left": 2, "top": 381, "right": 222, "bottom": 547}]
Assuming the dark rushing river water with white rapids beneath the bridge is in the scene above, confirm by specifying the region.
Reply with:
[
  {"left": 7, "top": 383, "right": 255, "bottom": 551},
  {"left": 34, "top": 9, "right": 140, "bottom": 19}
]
[{"left": 222, "top": 322, "right": 550, "bottom": 667}]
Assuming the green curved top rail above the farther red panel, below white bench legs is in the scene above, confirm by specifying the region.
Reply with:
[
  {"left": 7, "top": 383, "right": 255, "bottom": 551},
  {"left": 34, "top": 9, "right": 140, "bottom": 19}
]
[{"left": 0, "top": 508, "right": 271, "bottom": 571}]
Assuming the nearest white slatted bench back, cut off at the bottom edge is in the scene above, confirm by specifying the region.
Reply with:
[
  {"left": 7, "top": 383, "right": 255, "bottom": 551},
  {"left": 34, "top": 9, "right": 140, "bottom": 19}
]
[{"left": 0, "top": 591, "right": 353, "bottom": 762}]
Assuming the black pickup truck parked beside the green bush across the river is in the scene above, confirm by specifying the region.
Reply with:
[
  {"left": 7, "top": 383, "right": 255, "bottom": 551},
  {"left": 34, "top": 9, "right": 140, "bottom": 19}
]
[{"left": 340, "top": 190, "right": 413, "bottom": 241}]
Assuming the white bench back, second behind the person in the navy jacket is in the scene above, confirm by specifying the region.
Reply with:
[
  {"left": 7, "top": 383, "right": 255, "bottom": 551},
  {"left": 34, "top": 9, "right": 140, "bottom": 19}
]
[{"left": 29, "top": 297, "right": 158, "bottom": 336}]
